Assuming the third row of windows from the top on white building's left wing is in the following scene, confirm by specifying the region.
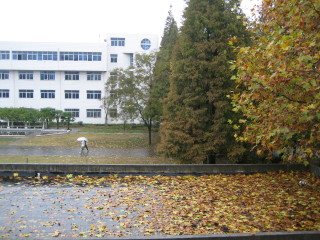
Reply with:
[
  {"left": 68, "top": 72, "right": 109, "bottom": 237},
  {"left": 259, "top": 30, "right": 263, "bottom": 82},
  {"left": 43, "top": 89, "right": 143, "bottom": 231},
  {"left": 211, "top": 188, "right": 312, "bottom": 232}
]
[{"left": 0, "top": 89, "right": 101, "bottom": 100}]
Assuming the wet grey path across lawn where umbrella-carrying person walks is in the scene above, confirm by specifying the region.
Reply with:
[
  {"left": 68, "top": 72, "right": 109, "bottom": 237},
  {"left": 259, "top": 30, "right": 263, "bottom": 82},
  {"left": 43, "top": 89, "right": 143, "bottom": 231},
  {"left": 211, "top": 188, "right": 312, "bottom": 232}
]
[{"left": 0, "top": 145, "right": 155, "bottom": 157}]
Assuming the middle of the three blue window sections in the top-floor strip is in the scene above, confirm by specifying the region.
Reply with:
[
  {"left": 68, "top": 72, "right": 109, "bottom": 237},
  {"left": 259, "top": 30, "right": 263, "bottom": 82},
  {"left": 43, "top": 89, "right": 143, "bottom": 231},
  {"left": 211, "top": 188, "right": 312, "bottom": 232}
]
[{"left": 12, "top": 51, "right": 58, "bottom": 61}]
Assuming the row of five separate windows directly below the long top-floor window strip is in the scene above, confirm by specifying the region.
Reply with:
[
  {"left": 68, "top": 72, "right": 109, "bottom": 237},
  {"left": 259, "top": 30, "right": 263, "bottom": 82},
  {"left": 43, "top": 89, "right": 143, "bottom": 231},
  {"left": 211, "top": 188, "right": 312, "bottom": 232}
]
[{"left": 0, "top": 70, "right": 102, "bottom": 81}]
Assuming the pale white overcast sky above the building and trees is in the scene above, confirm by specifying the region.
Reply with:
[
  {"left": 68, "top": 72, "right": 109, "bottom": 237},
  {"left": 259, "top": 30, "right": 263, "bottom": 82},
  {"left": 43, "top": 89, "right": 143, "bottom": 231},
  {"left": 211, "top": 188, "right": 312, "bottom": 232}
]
[{"left": 0, "top": 0, "right": 257, "bottom": 42}]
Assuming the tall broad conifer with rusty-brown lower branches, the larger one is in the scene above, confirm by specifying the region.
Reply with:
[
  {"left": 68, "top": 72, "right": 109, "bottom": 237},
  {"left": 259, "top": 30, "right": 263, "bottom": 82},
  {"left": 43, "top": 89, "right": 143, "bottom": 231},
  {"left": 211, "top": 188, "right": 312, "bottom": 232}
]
[{"left": 159, "top": 0, "right": 249, "bottom": 163}]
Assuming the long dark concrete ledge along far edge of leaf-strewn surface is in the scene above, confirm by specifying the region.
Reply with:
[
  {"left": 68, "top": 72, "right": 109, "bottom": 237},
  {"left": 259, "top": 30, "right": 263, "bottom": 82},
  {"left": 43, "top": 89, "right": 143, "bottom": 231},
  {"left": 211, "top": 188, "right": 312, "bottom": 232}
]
[{"left": 0, "top": 163, "right": 312, "bottom": 174}]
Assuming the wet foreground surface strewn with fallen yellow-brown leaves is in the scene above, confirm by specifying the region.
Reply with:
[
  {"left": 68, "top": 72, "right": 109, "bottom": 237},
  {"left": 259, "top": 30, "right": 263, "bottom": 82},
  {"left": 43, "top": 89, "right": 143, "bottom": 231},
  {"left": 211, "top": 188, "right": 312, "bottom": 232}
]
[{"left": 0, "top": 171, "right": 320, "bottom": 238}]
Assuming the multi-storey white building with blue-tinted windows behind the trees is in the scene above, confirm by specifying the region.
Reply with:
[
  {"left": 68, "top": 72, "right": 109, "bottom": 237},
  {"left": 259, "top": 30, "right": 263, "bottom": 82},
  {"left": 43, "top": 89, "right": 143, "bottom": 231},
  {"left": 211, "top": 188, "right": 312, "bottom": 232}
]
[{"left": 0, "top": 34, "right": 159, "bottom": 124}]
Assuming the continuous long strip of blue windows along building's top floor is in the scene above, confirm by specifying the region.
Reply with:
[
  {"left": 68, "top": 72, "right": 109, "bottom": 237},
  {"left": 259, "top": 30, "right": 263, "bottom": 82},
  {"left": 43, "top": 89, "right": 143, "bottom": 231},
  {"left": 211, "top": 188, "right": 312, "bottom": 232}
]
[{"left": 0, "top": 50, "right": 102, "bottom": 61}]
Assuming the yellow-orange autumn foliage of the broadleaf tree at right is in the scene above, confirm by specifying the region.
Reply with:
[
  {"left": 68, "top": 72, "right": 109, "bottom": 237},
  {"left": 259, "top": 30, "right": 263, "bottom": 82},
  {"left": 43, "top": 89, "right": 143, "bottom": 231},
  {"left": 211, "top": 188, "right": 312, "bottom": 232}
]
[{"left": 233, "top": 0, "right": 320, "bottom": 164}]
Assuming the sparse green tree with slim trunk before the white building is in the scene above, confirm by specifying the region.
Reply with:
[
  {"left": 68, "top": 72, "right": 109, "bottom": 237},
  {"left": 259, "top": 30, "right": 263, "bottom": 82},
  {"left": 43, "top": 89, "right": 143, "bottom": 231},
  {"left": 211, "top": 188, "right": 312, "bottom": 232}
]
[{"left": 104, "top": 53, "right": 157, "bottom": 144}]
